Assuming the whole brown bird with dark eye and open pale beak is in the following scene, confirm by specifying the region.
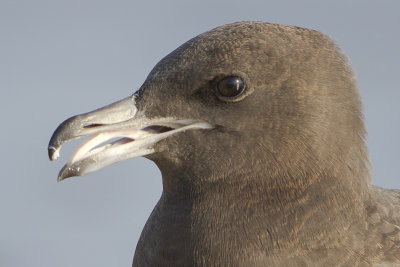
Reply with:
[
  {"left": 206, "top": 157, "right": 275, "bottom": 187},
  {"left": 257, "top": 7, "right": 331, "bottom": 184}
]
[{"left": 48, "top": 21, "right": 400, "bottom": 266}]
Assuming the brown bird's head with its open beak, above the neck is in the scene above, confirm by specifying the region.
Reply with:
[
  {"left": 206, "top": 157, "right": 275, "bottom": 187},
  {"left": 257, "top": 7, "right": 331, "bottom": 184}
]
[{"left": 49, "top": 22, "right": 366, "bottom": 196}]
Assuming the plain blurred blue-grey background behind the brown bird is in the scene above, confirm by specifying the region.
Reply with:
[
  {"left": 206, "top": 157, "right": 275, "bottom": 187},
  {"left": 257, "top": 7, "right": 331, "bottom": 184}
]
[{"left": 0, "top": 0, "right": 400, "bottom": 267}]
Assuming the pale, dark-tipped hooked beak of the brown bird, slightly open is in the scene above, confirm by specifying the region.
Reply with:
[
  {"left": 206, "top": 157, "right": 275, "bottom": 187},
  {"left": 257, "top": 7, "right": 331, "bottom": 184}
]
[{"left": 48, "top": 95, "right": 213, "bottom": 181}]
